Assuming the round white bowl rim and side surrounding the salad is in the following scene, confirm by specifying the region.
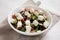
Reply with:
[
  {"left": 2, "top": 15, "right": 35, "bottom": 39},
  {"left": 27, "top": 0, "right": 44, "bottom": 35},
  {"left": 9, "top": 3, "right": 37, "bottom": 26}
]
[{"left": 8, "top": 6, "right": 52, "bottom": 36}]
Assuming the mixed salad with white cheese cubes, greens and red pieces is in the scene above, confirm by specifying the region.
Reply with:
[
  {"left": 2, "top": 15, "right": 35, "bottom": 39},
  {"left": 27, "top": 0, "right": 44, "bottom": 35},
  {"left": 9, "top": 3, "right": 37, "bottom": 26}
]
[{"left": 11, "top": 7, "right": 49, "bottom": 33}]
